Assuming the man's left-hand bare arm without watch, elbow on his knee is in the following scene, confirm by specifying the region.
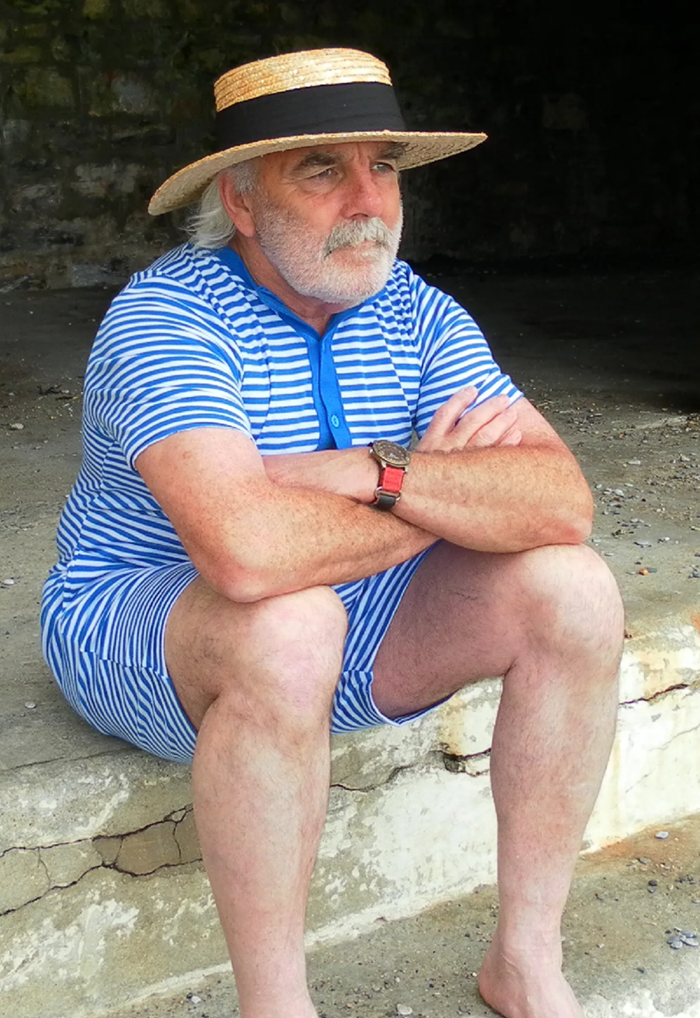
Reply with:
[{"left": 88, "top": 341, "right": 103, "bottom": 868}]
[{"left": 136, "top": 428, "right": 435, "bottom": 602}]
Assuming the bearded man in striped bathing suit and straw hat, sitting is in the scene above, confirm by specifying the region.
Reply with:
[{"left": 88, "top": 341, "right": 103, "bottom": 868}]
[{"left": 44, "top": 50, "right": 622, "bottom": 1018}]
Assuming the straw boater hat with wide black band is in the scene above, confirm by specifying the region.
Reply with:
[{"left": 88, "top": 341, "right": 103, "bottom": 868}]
[{"left": 149, "top": 49, "right": 486, "bottom": 216}]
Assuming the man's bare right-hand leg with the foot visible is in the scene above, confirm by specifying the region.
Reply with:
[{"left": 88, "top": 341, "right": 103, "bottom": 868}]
[{"left": 374, "top": 545, "right": 623, "bottom": 1018}]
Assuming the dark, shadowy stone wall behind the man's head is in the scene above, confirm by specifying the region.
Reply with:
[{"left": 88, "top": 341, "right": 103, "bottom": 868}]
[{"left": 0, "top": 0, "right": 700, "bottom": 288}]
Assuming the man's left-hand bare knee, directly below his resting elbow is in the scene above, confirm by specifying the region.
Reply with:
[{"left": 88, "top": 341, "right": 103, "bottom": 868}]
[{"left": 215, "top": 586, "right": 347, "bottom": 728}]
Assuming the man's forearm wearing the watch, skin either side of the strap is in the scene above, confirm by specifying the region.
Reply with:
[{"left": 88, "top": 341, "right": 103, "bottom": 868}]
[{"left": 266, "top": 437, "right": 592, "bottom": 552}]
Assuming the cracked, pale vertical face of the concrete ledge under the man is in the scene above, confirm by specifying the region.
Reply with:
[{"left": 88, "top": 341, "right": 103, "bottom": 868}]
[{"left": 0, "top": 624, "right": 700, "bottom": 1018}]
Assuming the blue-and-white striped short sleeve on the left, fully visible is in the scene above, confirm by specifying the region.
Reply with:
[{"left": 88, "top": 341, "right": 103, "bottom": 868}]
[{"left": 83, "top": 279, "right": 252, "bottom": 467}]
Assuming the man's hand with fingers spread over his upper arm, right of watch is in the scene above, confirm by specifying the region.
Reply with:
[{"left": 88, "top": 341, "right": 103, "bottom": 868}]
[{"left": 416, "top": 386, "right": 523, "bottom": 452}]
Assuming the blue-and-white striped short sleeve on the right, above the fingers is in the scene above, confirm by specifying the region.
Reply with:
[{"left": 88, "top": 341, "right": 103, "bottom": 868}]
[{"left": 414, "top": 277, "right": 522, "bottom": 437}]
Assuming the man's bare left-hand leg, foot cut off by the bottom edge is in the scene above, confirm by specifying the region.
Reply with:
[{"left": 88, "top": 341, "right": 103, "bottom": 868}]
[{"left": 166, "top": 580, "right": 346, "bottom": 1018}]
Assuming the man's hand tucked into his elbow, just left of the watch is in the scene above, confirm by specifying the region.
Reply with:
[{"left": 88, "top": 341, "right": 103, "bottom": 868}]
[{"left": 263, "top": 446, "right": 378, "bottom": 504}]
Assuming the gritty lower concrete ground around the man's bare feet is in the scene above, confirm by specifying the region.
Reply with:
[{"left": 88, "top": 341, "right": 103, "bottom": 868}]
[{"left": 95, "top": 816, "right": 700, "bottom": 1018}]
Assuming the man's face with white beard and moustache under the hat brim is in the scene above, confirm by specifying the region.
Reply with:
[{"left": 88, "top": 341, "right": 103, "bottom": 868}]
[{"left": 247, "top": 143, "right": 402, "bottom": 306}]
